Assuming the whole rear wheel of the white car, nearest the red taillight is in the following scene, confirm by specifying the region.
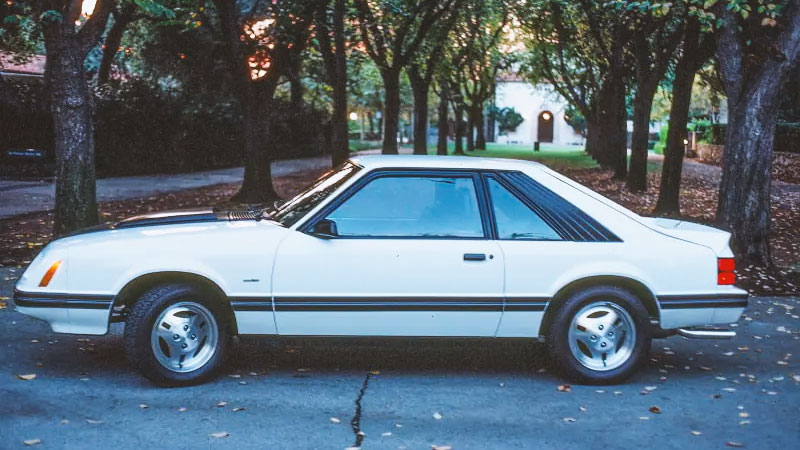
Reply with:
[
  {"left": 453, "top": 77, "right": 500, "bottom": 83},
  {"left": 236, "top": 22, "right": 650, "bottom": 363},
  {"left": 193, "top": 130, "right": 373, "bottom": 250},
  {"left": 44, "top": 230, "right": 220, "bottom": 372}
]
[{"left": 547, "top": 286, "right": 651, "bottom": 384}]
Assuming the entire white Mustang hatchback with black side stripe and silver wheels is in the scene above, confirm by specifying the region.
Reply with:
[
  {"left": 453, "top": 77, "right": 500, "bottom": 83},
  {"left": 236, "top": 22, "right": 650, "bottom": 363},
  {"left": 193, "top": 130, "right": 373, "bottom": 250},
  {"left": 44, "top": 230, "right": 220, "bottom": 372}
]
[{"left": 14, "top": 156, "right": 747, "bottom": 385}]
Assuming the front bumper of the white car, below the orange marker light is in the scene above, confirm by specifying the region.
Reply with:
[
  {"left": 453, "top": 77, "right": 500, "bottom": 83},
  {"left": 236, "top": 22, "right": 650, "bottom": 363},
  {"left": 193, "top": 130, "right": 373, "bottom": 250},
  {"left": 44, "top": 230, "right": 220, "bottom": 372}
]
[{"left": 11, "top": 289, "right": 114, "bottom": 335}]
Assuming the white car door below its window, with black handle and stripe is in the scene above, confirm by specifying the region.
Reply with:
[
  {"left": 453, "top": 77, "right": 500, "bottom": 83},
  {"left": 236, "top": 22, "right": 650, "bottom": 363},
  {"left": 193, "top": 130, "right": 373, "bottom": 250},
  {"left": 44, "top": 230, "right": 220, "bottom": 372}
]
[{"left": 273, "top": 233, "right": 504, "bottom": 336}]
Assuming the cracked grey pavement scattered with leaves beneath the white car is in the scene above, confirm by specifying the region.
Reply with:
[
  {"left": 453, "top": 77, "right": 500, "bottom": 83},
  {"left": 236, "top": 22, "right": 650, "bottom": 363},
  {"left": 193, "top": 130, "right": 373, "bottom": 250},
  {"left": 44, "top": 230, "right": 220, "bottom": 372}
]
[{"left": 0, "top": 269, "right": 800, "bottom": 450}]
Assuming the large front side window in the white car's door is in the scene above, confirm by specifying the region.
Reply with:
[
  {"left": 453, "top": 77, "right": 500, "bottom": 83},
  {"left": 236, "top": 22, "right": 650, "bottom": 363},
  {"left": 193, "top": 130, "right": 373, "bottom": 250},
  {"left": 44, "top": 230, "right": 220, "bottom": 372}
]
[{"left": 326, "top": 176, "right": 484, "bottom": 238}]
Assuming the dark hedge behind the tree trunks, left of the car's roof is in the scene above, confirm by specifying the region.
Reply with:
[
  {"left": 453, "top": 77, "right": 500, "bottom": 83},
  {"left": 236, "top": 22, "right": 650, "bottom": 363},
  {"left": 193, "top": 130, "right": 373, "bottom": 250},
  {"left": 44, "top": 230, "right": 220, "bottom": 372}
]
[{"left": 0, "top": 81, "right": 330, "bottom": 177}]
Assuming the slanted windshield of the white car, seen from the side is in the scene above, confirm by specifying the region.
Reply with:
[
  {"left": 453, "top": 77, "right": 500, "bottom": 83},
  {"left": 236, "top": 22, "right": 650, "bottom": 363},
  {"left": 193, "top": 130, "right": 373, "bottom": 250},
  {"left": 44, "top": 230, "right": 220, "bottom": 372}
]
[{"left": 269, "top": 161, "right": 360, "bottom": 228}]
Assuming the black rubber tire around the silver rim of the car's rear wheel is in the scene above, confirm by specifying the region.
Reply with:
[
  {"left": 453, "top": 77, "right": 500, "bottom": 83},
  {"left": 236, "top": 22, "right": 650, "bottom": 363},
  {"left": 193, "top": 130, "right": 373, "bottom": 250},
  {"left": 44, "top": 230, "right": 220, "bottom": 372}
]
[{"left": 546, "top": 286, "right": 652, "bottom": 384}]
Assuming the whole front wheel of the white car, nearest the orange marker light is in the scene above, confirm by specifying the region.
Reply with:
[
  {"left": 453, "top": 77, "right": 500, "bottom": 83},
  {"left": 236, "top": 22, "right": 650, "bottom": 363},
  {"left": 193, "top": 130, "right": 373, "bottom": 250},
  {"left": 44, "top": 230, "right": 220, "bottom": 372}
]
[{"left": 125, "top": 285, "right": 230, "bottom": 386}]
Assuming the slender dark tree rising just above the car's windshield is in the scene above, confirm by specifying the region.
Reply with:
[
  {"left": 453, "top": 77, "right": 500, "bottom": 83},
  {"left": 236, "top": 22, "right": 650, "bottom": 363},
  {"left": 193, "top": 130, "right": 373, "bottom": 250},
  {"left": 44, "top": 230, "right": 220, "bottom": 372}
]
[{"left": 315, "top": 0, "right": 350, "bottom": 165}]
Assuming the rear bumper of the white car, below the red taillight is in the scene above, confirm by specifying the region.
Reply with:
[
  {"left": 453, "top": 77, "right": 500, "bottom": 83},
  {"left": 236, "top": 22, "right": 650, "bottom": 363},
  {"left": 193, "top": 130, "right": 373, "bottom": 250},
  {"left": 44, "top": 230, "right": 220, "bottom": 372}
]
[{"left": 658, "top": 293, "right": 748, "bottom": 330}]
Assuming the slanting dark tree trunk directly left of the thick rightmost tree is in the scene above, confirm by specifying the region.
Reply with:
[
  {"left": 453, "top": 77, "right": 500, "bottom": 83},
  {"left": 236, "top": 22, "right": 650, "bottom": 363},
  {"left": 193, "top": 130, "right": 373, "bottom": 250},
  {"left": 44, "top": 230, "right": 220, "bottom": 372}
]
[{"left": 655, "top": 55, "right": 695, "bottom": 217}]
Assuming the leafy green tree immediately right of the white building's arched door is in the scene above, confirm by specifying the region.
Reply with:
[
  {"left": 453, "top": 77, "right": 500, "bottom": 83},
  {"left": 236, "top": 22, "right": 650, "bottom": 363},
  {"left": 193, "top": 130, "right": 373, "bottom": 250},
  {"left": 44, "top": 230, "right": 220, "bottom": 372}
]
[{"left": 515, "top": 0, "right": 634, "bottom": 179}]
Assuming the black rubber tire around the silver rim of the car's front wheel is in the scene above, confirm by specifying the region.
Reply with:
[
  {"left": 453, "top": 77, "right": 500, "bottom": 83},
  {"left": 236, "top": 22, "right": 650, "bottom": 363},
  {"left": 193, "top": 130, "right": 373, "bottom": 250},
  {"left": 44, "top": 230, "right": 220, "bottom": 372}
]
[{"left": 124, "top": 284, "right": 232, "bottom": 386}]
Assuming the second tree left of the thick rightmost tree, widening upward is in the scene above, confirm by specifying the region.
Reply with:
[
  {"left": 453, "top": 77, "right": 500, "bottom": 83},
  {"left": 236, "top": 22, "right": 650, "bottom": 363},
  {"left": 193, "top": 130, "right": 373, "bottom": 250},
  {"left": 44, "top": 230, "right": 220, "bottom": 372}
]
[{"left": 620, "top": 2, "right": 685, "bottom": 191}]
